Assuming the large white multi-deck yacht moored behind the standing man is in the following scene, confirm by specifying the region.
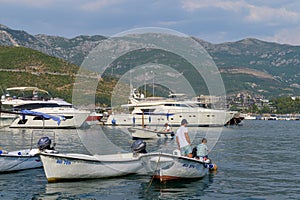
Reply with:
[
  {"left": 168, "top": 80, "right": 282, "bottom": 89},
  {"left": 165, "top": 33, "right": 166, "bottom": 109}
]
[{"left": 105, "top": 90, "right": 237, "bottom": 126}]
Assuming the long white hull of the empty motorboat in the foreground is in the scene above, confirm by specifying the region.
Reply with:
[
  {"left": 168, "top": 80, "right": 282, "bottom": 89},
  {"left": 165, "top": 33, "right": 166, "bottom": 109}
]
[{"left": 41, "top": 153, "right": 143, "bottom": 182}]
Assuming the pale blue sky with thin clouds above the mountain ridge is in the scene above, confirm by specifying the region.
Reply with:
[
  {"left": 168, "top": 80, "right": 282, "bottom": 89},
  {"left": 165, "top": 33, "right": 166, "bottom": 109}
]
[{"left": 0, "top": 0, "right": 300, "bottom": 45}]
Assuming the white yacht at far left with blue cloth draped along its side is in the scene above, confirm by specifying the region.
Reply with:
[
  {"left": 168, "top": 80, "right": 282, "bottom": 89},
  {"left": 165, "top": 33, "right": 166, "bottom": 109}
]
[{"left": 1, "top": 87, "right": 90, "bottom": 128}]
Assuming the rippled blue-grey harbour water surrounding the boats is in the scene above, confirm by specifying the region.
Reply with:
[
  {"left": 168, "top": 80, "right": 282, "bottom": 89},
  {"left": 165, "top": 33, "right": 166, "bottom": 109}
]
[{"left": 0, "top": 120, "right": 300, "bottom": 200}]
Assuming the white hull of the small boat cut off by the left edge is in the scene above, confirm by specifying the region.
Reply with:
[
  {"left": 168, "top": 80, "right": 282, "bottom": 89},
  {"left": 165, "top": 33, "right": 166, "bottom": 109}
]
[{"left": 0, "top": 149, "right": 42, "bottom": 173}]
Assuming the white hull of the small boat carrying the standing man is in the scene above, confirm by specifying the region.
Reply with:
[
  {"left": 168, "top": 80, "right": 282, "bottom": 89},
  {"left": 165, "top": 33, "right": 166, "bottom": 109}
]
[{"left": 142, "top": 153, "right": 209, "bottom": 181}]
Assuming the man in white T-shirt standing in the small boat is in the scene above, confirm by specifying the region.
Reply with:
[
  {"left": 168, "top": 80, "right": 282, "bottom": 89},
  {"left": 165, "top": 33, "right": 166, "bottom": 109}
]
[{"left": 176, "top": 119, "right": 192, "bottom": 157}]
